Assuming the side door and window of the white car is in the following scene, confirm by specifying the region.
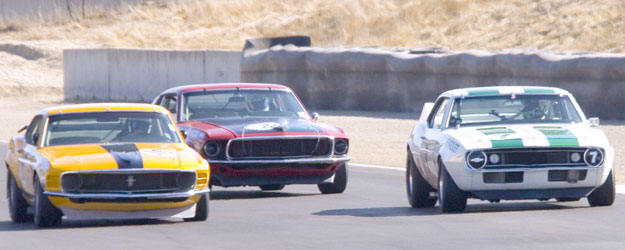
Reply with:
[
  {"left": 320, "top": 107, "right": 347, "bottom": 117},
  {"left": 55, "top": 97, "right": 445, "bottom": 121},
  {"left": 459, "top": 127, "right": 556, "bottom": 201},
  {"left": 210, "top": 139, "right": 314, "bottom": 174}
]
[{"left": 421, "top": 97, "right": 450, "bottom": 183}]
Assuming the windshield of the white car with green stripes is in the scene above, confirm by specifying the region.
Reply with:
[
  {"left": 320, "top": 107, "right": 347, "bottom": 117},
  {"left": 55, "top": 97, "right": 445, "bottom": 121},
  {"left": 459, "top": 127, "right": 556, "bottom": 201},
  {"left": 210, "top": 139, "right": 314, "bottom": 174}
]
[{"left": 449, "top": 94, "right": 581, "bottom": 127}]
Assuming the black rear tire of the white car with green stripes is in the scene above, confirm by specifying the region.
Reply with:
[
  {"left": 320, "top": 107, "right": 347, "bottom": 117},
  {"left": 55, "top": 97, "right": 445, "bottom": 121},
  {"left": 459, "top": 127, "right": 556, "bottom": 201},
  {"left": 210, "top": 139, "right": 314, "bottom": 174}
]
[{"left": 406, "top": 152, "right": 436, "bottom": 208}]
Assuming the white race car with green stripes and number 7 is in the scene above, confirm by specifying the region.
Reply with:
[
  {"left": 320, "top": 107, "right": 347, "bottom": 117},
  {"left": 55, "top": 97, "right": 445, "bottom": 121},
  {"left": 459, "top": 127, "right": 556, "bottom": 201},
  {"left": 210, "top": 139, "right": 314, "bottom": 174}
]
[{"left": 406, "top": 86, "right": 615, "bottom": 212}]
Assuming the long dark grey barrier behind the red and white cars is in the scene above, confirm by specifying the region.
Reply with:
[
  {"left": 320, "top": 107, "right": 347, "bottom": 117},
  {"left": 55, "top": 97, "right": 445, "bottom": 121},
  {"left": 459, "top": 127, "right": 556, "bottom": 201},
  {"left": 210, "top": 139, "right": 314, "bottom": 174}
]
[{"left": 241, "top": 45, "right": 625, "bottom": 120}]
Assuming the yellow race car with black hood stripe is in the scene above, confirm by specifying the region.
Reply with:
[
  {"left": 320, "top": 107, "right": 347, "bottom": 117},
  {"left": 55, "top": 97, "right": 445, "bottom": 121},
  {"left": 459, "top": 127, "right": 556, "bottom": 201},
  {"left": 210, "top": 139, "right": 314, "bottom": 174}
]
[{"left": 6, "top": 103, "right": 210, "bottom": 227}]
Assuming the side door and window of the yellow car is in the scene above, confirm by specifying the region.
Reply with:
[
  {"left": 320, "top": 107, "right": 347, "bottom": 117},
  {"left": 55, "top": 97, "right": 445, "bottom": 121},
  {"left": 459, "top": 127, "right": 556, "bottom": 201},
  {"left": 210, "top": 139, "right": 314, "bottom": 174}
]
[{"left": 16, "top": 115, "right": 44, "bottom": 196}]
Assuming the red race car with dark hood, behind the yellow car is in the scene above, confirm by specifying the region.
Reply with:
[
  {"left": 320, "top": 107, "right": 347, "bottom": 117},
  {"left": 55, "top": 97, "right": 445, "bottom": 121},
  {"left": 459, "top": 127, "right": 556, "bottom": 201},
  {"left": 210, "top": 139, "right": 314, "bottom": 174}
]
[{"left": 152, "top": 83, "right": 351, "bottom": 194}]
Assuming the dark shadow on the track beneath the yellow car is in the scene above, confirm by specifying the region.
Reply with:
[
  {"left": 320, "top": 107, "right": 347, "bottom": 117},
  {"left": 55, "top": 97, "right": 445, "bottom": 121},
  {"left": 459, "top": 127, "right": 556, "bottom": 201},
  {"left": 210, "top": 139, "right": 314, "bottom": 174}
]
[{"left": 0, "top": 219, "right": 176, "bottom": 232}]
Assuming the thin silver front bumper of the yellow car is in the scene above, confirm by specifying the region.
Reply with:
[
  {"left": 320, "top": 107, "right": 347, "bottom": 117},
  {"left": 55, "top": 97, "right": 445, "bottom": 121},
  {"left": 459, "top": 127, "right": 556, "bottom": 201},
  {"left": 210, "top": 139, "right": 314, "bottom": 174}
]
[{"left": 43, "top": 188, "right": 210, "bottom": 200}]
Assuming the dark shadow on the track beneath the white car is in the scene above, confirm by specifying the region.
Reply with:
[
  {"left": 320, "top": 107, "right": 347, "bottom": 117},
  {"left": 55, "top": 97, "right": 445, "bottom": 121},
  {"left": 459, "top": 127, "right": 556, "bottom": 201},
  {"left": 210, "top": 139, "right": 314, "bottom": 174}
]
[{"left": 313, "top": 202, "right": 588, "bottom": 217}]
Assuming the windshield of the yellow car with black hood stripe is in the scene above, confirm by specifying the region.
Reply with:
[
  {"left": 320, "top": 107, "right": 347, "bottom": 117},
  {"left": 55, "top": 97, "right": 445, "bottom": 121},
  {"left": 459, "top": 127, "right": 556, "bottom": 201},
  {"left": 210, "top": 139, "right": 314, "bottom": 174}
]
[{"left": 44, "top": 112, "right": 181, "bottom": 146}]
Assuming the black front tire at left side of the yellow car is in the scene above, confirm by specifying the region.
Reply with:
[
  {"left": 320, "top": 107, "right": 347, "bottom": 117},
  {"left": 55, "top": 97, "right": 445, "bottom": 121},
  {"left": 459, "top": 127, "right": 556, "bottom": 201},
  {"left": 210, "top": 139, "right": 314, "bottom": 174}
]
[{"left": 33, "top": 176, "right": 63, "bottom": 227}]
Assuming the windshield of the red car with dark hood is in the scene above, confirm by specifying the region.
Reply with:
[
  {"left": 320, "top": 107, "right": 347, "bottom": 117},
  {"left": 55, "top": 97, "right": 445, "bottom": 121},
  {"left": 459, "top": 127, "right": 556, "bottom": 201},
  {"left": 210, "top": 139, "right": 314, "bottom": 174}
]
[{"left": 181, "top": 90, "right": 308, "bottom": 121}]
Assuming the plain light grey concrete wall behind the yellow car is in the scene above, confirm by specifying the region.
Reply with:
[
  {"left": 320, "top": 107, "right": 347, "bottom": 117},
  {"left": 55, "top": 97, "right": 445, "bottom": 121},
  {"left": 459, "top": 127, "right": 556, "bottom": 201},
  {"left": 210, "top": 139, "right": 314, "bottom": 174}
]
[{"left": 63, "top": 49, "right": 241, "bottom": 102}]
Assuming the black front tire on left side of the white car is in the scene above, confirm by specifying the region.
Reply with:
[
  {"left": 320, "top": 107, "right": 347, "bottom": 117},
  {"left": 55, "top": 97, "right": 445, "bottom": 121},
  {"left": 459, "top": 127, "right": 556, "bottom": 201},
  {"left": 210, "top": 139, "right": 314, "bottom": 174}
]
[{"left": 438, "top": 160, "right": 467, "bottom": 213}]
